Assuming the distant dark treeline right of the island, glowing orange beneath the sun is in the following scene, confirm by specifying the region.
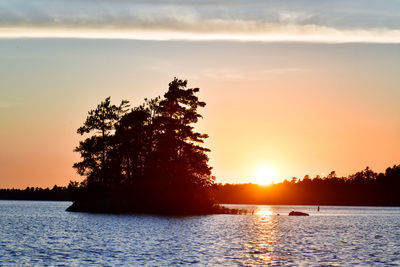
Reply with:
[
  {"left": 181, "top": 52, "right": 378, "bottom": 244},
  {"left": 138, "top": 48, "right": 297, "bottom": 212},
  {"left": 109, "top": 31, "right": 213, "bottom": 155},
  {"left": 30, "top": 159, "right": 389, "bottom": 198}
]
[{"left": 214, "top": 165, "right": 400, "bottom": 206}]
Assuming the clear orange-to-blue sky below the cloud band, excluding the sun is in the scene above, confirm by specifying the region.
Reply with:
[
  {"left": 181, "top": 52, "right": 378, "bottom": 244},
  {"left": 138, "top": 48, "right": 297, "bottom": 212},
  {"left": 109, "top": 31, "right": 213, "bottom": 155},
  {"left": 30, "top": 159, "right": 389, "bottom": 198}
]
[{"left": 0, "top": 39, "right": 400, "bottom": 188}]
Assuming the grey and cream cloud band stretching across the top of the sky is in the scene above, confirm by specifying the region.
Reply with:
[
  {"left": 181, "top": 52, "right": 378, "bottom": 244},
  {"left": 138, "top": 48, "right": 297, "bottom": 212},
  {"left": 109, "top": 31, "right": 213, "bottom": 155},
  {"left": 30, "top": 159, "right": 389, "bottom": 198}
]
[{"left": 0, "top": 0, "right": 400, "bottom": 43}]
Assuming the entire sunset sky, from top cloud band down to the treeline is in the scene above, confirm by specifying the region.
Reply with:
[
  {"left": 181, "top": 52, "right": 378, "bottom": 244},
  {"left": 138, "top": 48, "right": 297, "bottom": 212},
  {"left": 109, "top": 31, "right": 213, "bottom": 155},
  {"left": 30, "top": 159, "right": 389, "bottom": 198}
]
[{"left": 0, "top": 0, "right": 400, "bottom": 188}]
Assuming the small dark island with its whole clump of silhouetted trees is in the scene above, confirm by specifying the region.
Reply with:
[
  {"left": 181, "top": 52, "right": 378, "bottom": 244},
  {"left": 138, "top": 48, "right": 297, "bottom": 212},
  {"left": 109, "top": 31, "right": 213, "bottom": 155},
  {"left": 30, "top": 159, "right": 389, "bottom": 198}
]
[{"left": 69, "top": 78, "right": 233, "bottom": 214}]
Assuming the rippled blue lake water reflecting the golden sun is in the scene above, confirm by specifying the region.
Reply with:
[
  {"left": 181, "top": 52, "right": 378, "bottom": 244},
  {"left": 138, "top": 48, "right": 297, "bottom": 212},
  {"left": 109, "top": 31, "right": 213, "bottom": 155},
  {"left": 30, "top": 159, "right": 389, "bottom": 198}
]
[{"left": 0, "top": 201, "right": 400, "bottom": 266}]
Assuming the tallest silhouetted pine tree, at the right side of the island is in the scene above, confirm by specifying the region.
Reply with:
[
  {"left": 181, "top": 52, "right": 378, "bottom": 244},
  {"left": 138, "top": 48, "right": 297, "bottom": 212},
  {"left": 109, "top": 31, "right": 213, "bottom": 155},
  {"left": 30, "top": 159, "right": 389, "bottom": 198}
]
[{"left": 154, "top": 78, "right": 213, "bottom": 187}]
